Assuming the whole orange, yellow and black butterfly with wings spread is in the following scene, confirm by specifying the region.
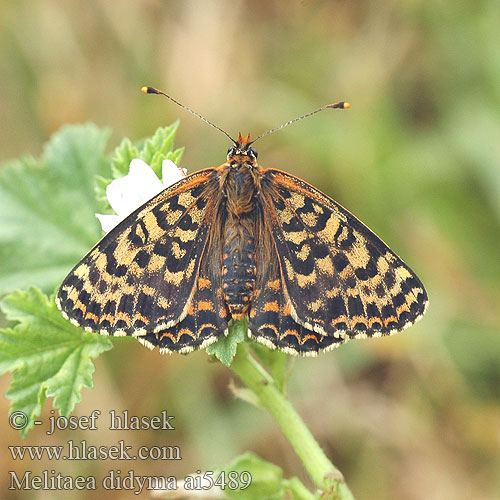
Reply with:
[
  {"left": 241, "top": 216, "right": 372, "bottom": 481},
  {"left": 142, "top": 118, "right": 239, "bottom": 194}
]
[{"left": 57, "top": 87, "right": 427, "bottom": 355}]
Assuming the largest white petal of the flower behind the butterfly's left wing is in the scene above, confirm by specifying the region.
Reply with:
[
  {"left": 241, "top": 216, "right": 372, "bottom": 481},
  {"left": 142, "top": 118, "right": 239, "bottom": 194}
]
[{"left": 106, "top": 158, "right": 164, "bottom": 217}]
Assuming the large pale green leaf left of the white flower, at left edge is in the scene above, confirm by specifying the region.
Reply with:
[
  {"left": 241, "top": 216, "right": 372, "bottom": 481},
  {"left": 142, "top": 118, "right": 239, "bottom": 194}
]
[{"left": 0, "top": 125, "right": 109, "bottom": 293}]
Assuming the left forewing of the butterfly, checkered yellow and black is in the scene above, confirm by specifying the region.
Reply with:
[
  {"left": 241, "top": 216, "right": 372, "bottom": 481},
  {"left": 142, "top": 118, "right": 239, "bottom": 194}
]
[{"left": 57, "top": 169, "right": 215, "bottom": 336}]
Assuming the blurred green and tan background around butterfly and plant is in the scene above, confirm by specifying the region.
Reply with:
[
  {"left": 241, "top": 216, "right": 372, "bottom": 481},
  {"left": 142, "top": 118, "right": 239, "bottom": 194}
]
[{"left": 0, "top": 0, "right": 500, "bottom": 500}]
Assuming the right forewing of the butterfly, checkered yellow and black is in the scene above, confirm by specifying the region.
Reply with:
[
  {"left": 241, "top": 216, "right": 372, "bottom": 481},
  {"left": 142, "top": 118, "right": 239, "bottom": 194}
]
[{"left": 262, "top": 170, "right": 427, "bottom": 339}]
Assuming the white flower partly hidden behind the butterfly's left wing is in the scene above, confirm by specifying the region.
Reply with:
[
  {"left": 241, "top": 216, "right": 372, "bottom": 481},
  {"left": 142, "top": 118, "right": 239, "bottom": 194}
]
[{"left": 95, "top": 158, "right": 187, "bottom": 233}]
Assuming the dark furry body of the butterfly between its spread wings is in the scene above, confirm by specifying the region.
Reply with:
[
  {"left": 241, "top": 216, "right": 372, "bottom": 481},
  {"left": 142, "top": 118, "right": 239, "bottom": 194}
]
[{"left": 221, "top": 145, "right": 260, "bottom": 319}]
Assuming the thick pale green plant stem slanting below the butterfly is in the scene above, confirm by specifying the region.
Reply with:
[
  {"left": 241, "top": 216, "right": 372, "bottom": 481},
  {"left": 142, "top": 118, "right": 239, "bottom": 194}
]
[{"left": 231, "top": 342, "right": 354, "bottom": 500}]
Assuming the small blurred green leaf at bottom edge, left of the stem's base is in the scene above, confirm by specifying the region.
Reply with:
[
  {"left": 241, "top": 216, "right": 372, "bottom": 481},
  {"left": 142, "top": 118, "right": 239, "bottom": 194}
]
[{"left": 220, "top": 452, "right": 285, "bottom": 500}]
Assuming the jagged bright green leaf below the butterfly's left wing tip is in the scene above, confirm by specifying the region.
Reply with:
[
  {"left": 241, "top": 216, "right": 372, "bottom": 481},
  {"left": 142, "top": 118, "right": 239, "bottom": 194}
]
[{"left": 0, "top": 288, "right": 113, "bottom": 436}]
